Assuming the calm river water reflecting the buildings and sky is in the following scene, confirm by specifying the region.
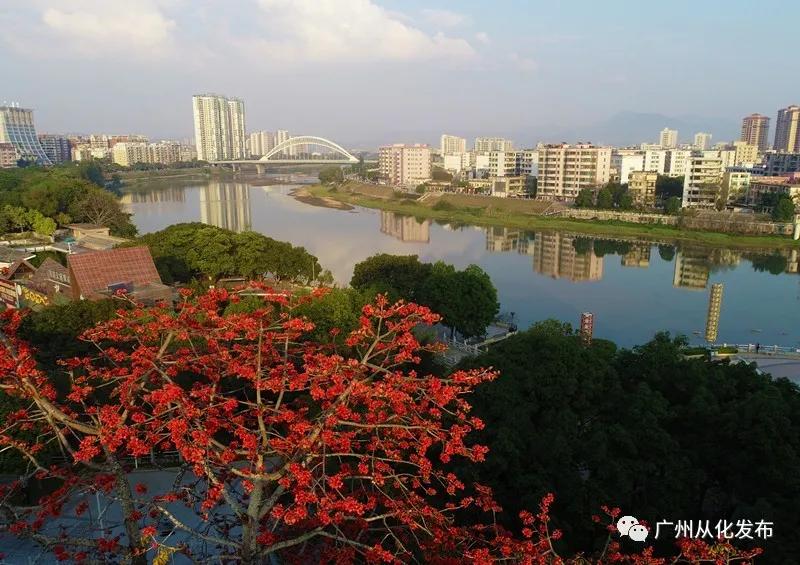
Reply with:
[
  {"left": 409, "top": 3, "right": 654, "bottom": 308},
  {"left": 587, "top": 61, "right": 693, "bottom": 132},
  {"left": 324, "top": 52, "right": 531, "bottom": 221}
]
[{"left": 123, "top": 178, "right": 800, "bottom": 347}]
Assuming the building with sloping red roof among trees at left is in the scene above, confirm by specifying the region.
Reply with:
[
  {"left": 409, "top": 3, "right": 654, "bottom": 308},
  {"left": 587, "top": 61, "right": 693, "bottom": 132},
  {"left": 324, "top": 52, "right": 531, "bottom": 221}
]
[{"left": 67, "top": 247, "right": 172, "bottom": 303}]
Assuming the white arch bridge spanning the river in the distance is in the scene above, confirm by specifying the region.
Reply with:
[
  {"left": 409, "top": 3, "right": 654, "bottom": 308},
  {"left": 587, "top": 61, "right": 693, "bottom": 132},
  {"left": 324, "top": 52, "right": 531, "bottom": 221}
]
[{"left": 211, "top": 135, "right": 358, "bottom": 174}]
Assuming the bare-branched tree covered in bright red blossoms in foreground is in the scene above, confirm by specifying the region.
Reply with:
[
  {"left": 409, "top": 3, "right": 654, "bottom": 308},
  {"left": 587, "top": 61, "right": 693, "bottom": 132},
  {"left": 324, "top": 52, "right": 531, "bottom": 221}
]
[{"left": 0, "top": 287, "right": 764, "bottom": 564}]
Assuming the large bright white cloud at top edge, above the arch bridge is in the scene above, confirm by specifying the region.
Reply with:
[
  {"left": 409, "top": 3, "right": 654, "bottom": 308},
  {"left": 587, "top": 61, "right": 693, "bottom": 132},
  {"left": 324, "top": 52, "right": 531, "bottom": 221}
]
[{"left": 250, "top": 0, "right": 475, "bottom": 63}]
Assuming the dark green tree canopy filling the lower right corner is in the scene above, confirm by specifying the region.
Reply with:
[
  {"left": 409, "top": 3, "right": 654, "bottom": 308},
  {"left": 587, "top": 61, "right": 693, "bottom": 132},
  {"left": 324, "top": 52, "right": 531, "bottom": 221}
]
[{"left": 462, "top": 321, "right": 800, "bottom": 563}]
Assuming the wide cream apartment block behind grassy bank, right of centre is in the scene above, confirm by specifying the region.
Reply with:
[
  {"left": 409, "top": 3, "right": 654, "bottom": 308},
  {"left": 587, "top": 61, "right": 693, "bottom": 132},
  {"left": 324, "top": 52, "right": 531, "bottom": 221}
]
[{"left": 537, "top": 143, "right": 611, "bottom": 201}]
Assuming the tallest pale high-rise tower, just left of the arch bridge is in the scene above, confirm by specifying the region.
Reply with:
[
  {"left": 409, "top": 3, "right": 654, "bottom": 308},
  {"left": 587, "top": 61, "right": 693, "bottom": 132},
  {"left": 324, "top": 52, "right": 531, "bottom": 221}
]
[{"left": 192, "top": 94, "right": 246, "bottom": 161}]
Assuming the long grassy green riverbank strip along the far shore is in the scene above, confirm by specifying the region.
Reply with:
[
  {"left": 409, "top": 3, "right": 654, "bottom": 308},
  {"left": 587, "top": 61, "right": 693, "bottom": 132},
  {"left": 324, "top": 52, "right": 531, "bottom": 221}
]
[{"left": 307, "top": 183, "right": 800, "bottom": 249}]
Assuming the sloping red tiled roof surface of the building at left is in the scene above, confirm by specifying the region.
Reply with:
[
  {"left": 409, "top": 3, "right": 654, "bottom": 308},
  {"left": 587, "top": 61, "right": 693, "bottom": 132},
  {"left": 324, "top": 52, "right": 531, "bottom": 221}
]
[{"left": 67, "top": 247, "right": 161, "bottom": 297}]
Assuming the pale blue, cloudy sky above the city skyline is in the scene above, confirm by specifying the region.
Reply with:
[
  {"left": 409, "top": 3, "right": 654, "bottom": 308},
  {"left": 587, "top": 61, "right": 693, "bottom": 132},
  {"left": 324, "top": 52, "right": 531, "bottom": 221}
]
[{"left": 0, "top": 0, "right": 800, "bottom": 149}]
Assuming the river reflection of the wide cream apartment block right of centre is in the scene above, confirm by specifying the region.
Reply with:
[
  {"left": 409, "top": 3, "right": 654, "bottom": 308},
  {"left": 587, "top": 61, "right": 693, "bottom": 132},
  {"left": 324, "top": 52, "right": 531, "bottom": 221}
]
[{"left": 533, "top": 233, "right": 603, "bottom": 282}]
